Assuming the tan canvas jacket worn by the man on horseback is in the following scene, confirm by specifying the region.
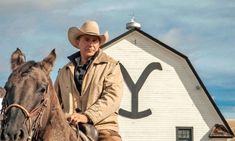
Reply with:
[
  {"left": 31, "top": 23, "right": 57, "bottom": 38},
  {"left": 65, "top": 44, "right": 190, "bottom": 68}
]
[{"left": 55, "top": 50, "right": 123, "bottom": 131}]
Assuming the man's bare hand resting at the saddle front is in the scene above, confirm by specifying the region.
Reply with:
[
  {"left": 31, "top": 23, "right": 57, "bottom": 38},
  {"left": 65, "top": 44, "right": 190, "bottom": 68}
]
[{"left": 67, "top": 113, "right": 89, "bottom": 125}]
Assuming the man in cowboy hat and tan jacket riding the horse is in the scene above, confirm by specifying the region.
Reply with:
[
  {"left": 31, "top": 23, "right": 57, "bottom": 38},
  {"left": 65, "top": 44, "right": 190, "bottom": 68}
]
[{"left": 55, "top": 21, "right": 123, "bottom": 141}]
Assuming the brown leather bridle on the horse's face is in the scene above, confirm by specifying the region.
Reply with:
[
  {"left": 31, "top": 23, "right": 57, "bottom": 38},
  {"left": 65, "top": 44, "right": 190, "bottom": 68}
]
[{"left": 1, "top": 87, "right": 49, "bottom": 141}]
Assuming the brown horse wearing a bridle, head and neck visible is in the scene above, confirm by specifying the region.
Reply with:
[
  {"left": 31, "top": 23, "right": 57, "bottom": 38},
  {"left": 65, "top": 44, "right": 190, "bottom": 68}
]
[{"left": 1, "top": 49, "right": 97, "bottom": 141}]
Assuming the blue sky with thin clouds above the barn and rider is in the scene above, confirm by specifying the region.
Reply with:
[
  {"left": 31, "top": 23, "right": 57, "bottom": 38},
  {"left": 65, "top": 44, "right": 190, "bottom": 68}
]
[{"left": 0, "top": 0, "right": 235, "bottom": 119}]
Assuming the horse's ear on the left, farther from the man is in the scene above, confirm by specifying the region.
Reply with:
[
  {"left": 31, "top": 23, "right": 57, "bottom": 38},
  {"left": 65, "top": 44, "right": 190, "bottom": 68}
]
[{"left": 11, "top": 48, "right": 25, "bottom": 71}]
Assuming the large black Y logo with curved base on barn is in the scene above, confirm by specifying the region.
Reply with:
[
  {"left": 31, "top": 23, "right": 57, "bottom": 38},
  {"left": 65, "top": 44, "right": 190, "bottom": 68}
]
[{"left": 119, "top": 62, "right": 162, "bottom": 119}]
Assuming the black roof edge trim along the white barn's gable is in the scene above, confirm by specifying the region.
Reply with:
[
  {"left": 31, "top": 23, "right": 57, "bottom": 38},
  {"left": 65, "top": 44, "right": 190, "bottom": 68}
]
[{"left": 101, "top": 28, "right": 234, "bottom": 138}]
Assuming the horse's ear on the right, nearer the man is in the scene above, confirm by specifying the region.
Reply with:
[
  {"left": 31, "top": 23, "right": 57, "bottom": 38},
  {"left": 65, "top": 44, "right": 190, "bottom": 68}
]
[{"left": 41, "top": 49, "right": 56, "bottom": 74}]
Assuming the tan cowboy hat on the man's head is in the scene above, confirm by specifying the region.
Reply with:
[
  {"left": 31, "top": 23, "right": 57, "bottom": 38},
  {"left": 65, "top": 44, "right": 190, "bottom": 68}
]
[{"left": 68, "top": 21, "right": 109, "bottom": 48}]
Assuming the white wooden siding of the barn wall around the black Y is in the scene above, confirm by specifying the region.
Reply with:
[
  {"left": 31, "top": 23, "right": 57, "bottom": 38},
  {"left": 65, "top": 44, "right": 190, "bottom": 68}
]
[{"left": 104, "top": 32, "right": 226, "bottom": 141}]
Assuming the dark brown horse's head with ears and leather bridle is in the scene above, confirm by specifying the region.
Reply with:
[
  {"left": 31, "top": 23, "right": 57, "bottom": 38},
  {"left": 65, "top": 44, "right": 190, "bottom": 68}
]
[{"left": 1, "top": 49, "right": 56, "bottom": 141}]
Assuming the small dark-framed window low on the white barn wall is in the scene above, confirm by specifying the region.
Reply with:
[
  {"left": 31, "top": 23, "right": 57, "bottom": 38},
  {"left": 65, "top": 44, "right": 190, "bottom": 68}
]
[{"left": 176, "top": 127, "right": 193, "bottom": 141}]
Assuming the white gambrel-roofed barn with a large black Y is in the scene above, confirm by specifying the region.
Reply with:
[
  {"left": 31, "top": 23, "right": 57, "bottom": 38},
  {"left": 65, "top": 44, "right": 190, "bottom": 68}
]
[{"left": 102, "top": 25, "right": 234, "bottom": 141}]
